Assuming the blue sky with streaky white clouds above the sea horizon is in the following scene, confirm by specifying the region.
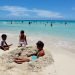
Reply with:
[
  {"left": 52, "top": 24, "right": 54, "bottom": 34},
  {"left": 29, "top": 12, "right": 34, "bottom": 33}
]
[{"left": 0, "top": 0, "right": 75, "bottom": 20}]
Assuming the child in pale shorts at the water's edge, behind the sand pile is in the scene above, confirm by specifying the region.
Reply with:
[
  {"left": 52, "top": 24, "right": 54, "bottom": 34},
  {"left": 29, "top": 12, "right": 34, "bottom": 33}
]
[{"left": 18, "top": 30, "right": 27, "bottom": 47}]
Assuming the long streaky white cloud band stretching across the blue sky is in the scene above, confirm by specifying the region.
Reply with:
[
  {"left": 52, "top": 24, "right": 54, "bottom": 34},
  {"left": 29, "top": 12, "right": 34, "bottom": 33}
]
[{"left": 0, "top": 6, "right": 63, "bottom": 18}]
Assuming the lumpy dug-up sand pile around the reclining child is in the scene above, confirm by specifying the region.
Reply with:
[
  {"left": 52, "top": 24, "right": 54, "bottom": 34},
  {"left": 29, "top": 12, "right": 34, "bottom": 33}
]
[{"left": 0, "top": 47, "right": 55, "bottom": 75}]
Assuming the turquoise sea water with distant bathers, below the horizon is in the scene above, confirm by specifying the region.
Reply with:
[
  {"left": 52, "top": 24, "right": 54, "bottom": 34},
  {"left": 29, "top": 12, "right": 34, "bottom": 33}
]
[{"left": 0, "top": 20, "right": 75, "bottom": 39}]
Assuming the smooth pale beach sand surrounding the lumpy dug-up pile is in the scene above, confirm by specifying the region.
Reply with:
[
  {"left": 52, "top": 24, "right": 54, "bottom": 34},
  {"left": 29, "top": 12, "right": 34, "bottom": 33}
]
[{"left": 0, "top": 35, "right": 75, "bottom": 75}]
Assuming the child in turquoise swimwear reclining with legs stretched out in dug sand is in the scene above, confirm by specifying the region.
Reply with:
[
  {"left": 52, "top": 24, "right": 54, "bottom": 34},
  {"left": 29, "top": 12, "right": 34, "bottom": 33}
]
[{"left": 14, "top": 41, "right": 45, "bottom": 64}]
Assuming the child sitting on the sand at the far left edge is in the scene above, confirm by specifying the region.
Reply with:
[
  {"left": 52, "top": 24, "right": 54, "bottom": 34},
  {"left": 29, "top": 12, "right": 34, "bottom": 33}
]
[{"left": 0, "top": 34, "right": 12, "bottom": 51}]
